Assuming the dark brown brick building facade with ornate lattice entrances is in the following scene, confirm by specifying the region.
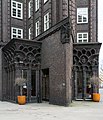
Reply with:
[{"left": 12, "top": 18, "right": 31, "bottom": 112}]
[{"left": 0, "top": 0, "right": 101, "bottom": 106}]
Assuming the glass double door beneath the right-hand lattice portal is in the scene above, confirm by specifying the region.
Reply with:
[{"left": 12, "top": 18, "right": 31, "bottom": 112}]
[{"left": 75, "top": 71, "right": 92, "bottom": 100}]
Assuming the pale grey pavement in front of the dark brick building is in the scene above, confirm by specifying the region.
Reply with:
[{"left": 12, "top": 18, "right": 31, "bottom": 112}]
[{"left": 0, "top": 90, "right": 103, "bottom": 120}]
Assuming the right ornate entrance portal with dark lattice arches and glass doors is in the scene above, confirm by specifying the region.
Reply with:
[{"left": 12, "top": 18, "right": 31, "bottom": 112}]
[{"left": 73, "top": 43, "right": 101, "bottom": 100}]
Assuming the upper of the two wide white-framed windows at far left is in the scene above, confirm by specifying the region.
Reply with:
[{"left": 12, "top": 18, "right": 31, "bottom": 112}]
[{"left": 11, "top": 0, "right": 23, "bottom": 19}]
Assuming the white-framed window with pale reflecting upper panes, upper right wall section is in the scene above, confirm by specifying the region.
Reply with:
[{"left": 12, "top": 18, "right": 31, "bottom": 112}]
[{"left": 77, "top": 8, "right": 88, "bottom": 24}]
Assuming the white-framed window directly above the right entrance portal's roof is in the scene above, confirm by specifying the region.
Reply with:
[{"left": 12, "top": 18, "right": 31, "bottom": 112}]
[{"left": 77, "top": 32, "right": 88, "bottom": 43}]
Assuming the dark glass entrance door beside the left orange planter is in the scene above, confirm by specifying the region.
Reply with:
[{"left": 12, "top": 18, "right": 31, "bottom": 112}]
[{"left": 22, "top": 70, "right": 37, "bottom": 102}]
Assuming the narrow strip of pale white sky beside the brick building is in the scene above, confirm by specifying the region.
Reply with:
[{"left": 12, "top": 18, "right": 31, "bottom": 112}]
[{"left": 98, "top": 0, "right": 103, "bottom": 66}]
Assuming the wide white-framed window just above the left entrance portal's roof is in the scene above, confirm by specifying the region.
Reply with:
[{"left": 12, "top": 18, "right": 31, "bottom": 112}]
[{"left": 11, "top": 27, "right": 23, "bottom": 38}]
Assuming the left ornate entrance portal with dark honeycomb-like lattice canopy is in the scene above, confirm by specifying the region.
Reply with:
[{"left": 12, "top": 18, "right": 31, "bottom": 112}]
[{"left": 2, "top": 39, "right": 41, "bottom": 102}]
